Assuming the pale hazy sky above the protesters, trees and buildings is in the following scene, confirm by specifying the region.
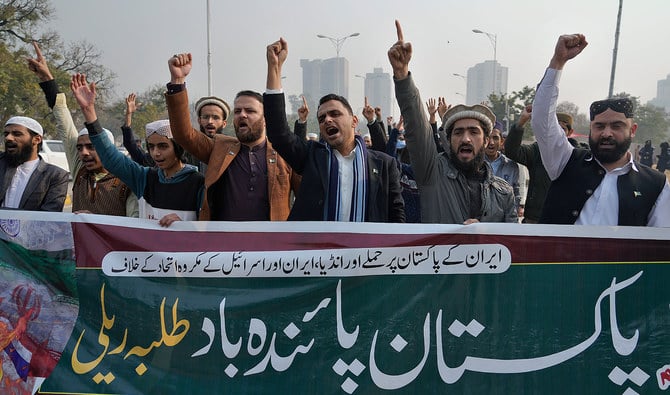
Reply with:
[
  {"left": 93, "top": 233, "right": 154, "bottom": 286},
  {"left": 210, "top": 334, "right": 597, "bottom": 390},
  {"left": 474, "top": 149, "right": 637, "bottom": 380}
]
[{"left": 50, "top": 0, "right": 670, "bottom": 116}]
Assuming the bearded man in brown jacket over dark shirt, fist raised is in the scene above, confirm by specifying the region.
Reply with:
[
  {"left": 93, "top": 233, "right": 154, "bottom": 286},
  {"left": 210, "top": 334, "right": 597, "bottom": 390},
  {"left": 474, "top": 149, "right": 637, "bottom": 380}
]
[{"left": 165, "top": 53, "right": 299, "bottom": 221}]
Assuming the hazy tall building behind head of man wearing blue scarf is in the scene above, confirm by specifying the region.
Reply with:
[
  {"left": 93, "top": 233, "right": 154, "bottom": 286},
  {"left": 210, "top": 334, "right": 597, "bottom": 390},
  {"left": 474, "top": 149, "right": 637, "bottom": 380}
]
[{"left": 300, "top": 57, "right": 349, "bottom": 103}]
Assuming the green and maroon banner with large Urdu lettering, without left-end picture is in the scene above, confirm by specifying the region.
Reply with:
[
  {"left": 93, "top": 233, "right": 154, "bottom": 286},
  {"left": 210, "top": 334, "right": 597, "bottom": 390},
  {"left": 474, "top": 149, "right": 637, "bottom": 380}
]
[{"left": 0, "top": 213, "right": 670, "bottom": 395}]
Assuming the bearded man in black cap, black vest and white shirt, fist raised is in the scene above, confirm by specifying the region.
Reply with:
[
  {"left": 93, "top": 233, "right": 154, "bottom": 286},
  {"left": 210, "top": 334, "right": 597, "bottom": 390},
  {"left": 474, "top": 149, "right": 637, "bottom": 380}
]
[{"left": 531, "top": 34, "right": 670, "bottom": 227}]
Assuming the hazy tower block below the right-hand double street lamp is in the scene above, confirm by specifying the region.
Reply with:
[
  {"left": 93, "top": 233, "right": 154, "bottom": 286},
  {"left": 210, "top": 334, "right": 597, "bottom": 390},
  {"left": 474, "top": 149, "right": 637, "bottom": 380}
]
[{"left": 465, "top": 60, "right": 508, "bottom": 105}]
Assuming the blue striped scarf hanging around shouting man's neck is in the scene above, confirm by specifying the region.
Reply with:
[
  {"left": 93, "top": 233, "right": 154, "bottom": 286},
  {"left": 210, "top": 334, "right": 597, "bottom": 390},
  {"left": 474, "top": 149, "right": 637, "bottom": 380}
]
[{"left": 323, "top": 135, "right": 368, "bottom": 222}]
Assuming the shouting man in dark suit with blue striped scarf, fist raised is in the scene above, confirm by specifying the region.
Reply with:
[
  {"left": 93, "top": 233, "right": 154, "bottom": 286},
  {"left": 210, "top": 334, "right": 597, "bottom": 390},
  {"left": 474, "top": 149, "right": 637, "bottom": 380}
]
[{"left": 263, "top": 38, "right": 405, "bottom": 222}]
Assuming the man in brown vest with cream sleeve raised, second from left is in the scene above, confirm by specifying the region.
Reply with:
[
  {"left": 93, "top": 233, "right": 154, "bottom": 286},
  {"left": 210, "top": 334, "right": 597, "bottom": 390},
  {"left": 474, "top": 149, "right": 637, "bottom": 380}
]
[{"left": 28, "top": 42, "right": 139, "bottom": 217}]
